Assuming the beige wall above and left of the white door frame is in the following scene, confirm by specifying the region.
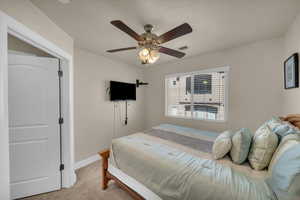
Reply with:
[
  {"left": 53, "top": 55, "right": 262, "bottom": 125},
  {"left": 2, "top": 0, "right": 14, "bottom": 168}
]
[{"left": 0, "top": 0, "right": 73, "bottom": 200}]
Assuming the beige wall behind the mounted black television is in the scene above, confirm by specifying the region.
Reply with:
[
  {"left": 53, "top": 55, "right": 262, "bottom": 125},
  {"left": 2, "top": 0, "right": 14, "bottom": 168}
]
[{"left": 74, "top": 48, "right": 145, "bottom": 161}]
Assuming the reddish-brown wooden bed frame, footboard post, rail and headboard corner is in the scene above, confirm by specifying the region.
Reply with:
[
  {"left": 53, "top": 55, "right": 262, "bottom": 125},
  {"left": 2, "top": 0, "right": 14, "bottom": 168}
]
[{"left": 99, "top": 114, "right": 300, "bottom": 200}]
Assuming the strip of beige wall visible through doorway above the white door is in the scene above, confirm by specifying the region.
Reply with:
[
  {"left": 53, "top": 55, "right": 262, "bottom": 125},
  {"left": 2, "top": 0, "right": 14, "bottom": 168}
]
[{"left": 7, "top": 35, "right": 53, "bottom": 57}]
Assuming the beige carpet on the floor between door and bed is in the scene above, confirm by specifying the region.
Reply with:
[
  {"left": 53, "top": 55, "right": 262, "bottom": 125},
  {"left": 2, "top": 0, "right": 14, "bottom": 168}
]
[{"left": 24, "top": 162, "right": 132, "bottom": 200}]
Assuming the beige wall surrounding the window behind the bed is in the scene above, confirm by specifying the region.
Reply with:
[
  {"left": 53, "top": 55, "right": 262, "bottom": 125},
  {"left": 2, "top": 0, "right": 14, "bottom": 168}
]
[{"left": 145, "top": 38, "right": 283, "bottom": 134}]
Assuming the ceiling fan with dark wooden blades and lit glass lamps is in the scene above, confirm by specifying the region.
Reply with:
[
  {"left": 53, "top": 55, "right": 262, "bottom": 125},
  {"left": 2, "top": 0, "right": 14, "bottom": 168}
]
[{"left": 107, "top": 20, "right": 192, "bottom": 64}]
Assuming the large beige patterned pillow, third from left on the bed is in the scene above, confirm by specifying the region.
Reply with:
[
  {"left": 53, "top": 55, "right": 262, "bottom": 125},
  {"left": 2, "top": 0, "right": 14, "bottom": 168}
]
[{"left": 248, "top": 125, "right": 278, "bottom": 170}]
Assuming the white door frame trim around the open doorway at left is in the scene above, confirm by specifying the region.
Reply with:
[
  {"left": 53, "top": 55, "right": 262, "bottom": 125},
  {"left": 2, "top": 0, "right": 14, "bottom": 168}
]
[{"left": 0, "top": 11, "right": 76, "bottom": 197}]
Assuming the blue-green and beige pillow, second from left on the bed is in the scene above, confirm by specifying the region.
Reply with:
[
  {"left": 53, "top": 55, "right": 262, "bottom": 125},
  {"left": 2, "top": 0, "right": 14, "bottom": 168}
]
[{"left": 230, "top": 128, "right": 252, "bottom": 164}]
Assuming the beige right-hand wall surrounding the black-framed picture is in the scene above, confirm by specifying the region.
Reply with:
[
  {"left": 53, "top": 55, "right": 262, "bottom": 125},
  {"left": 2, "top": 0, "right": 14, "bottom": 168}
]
[{"left": 281, "top": 14, "right": 300, "bottom": 115}]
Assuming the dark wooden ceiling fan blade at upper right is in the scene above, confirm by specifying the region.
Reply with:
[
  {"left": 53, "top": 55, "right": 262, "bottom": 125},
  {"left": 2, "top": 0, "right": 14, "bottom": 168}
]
[{"left": 158, "top": 23, "right": 193, "bottom": 44}]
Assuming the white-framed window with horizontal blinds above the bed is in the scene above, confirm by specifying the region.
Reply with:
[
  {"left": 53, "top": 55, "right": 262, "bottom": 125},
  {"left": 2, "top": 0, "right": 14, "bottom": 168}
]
[{"left": 165, "top": 67, "right": 229, "bottom": 121}]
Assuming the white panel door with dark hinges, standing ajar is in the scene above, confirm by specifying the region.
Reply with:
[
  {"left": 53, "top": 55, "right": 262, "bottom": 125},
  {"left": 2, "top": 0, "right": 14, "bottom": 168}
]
[{"left": 8, "top": 54, "right": 61, "bottom": 199}]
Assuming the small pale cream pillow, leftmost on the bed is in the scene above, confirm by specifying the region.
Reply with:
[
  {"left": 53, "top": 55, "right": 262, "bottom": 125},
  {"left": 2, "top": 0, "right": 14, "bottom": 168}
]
[{"left": 212, "top": 131, "right": 232, "bottom": 159}]
